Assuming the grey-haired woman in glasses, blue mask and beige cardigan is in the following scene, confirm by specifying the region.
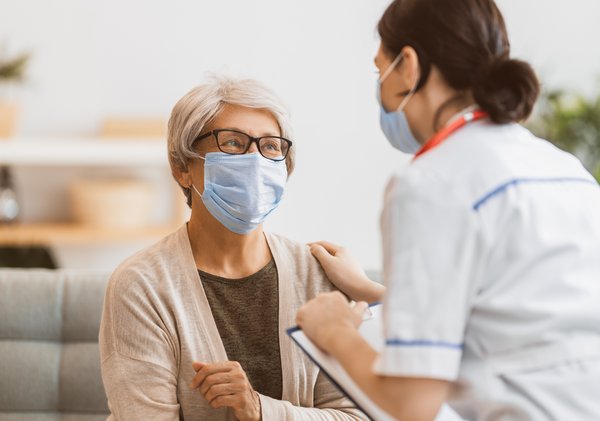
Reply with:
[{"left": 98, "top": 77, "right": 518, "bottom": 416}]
[{"left": 100, "top": 77, "right": 364, "bottom": 421}]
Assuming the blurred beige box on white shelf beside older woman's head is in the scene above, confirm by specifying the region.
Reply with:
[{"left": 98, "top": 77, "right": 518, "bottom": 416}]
[{"left": 100, "top": 117, "right": 167, "bottom": 139}]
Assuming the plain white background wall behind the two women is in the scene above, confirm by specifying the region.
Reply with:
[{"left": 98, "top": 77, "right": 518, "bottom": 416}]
[{"left": 0, "top": 0, "right": 600, "bottom": 268}]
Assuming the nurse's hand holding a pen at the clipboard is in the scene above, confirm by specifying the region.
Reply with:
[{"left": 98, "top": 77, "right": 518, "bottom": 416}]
[{"left": 296, "top": 291, "right": 367, "bottom": 352}]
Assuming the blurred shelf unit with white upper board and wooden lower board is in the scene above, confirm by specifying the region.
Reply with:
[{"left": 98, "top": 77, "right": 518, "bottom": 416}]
[{"left": 0, "top": 138, "right": 185, "bottom": 246}]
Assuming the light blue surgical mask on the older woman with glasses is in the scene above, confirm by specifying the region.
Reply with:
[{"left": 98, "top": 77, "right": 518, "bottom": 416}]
[{"left": 192, "top": 152, "right": 287, "bottom": 234}]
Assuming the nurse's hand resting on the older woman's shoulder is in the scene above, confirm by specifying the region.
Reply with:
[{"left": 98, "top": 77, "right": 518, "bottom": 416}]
[{"left": 308, "top": 241, "right": 385, "bottom": 303}]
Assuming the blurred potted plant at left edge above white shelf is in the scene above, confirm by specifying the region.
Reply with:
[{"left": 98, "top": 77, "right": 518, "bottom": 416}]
[{"left": 0, "top": 49, "right": 29, "bottom": 138}]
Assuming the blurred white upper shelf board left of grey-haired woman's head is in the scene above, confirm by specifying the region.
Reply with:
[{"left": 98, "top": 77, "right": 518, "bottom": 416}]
[{"left": 0, "top": 138, "right": 169, "bottom": 167}]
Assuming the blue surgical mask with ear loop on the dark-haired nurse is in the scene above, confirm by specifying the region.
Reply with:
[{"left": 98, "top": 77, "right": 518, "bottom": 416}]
[{"left": 377, "top": 53, "right": 421, "bottom": 154}]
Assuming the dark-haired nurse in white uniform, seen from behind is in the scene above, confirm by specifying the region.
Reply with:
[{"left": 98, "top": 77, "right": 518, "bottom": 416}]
[{"left": 297, "top": 0, "right": 600, "bottom": 421}]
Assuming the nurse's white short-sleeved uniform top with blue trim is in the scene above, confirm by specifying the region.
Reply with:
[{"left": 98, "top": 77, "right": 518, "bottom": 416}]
[{"left": 375, "top": 120, "right": 600, "bottom": 421}]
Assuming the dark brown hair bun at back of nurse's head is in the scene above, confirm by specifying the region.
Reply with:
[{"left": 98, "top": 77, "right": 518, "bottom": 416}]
[{"left": 473, "top": 57, "right": 540, "bottom": 124}]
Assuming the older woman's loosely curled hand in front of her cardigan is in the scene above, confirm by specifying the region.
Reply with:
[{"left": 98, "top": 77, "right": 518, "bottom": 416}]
[{"left": 190, "top": 361, "right": 261, "bottom": 421}]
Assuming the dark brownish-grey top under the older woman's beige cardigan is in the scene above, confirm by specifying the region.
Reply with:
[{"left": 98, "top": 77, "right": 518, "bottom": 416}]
[{"left": 198, "top": 260, "right": 282, "bottom": 399}]
